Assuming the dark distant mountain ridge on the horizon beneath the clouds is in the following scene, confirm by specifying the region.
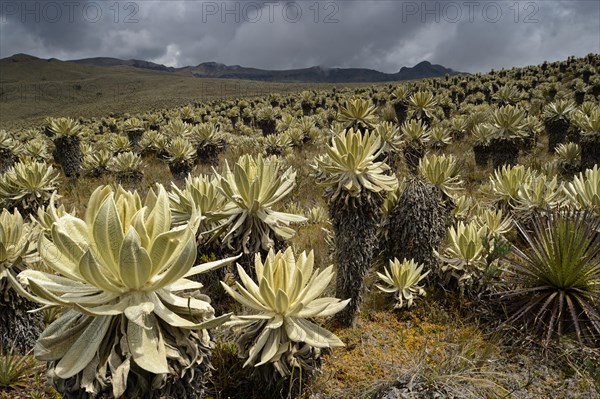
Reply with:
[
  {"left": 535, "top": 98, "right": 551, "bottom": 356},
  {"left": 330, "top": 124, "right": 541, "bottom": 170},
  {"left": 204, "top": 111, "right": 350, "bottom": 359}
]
[{"left": 69, "top": 57, "right": 460, "bottom": 83}]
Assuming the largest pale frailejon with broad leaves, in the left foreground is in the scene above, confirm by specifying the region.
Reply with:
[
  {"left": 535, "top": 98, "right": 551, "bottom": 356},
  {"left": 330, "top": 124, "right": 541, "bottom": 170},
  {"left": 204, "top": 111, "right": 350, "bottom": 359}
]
[{"left": 18, "top": 185, "right": 235, "bottom": 398}]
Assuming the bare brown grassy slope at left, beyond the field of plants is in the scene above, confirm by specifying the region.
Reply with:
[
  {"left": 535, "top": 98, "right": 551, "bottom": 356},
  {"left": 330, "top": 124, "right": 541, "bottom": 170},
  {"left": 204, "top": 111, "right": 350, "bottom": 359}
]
[{"left": 0, "top": 55, "right": 333, "bottom": 129}]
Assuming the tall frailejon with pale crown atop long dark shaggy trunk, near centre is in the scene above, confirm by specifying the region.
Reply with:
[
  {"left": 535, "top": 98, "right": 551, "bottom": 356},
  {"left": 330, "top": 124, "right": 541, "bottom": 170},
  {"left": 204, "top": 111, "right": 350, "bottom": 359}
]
[{"left": 313, "top": 129, "right": 398, "bottom": 325}]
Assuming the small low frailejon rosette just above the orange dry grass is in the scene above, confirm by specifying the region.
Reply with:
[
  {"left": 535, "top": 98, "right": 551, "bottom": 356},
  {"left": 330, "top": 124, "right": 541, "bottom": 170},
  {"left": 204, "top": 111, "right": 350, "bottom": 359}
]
[{"left": 375, "top": 258, "right": 431, "bottom": 309}]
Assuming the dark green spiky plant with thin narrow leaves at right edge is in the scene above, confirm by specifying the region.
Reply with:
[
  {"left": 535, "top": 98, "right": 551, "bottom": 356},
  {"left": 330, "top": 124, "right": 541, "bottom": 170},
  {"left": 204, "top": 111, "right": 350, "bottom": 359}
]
[{"left": 502, "top": 210, "right": 600, "bottom": 345}]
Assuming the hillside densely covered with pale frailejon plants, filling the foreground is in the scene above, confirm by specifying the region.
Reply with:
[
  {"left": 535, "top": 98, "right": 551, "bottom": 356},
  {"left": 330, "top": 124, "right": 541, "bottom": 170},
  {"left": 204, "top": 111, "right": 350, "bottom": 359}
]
[{"left": 0, "top": 54, "right": 600, "bottom": 399}]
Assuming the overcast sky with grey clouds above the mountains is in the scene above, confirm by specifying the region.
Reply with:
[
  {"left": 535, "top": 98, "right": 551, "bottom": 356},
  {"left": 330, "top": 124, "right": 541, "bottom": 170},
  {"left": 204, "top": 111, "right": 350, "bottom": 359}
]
[{"left": 0, "top": 0, "right": 600, "bottom": 73}]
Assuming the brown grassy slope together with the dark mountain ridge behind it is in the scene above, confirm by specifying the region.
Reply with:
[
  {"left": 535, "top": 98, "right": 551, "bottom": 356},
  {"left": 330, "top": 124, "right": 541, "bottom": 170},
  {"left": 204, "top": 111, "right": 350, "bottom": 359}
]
[{"left": 0, "top": 54, "right": 462, "bottom": 129}]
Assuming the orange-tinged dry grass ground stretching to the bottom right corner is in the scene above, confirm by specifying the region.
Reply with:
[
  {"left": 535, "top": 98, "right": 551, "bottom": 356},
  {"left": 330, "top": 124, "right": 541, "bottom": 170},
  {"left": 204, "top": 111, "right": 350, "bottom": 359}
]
[{"left": 305, "top": 298, "right": 600, "bottom": 399}]
